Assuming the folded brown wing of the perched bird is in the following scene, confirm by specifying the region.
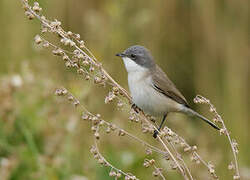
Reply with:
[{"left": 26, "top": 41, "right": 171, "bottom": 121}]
[{"left": 152, "top": 65, "right": 189, "bottom": 107}]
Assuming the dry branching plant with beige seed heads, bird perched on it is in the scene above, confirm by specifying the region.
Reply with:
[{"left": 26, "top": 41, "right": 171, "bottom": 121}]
[{"left": 21, "top": 0, "right": 240, "bottom": 180}]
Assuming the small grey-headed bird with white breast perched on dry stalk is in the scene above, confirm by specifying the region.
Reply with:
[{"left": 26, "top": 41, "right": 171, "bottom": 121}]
[{"left": 116, "top": 45, "right": 220, "bottom": 138}]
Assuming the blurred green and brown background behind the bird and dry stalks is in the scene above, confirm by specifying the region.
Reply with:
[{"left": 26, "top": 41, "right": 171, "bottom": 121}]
[{"left": 0, "top": 0, "right": 250, "bottom": 180}]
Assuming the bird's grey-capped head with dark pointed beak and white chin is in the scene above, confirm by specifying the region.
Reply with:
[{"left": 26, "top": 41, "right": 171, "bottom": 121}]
[{"left": 116, "top": 45, "right": 155, "bottom": 71}]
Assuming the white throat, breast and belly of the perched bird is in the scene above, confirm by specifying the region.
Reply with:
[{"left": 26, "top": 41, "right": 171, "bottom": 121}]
[{"left": 123, "top": 58, "right": 182, "bottom": 116}]
